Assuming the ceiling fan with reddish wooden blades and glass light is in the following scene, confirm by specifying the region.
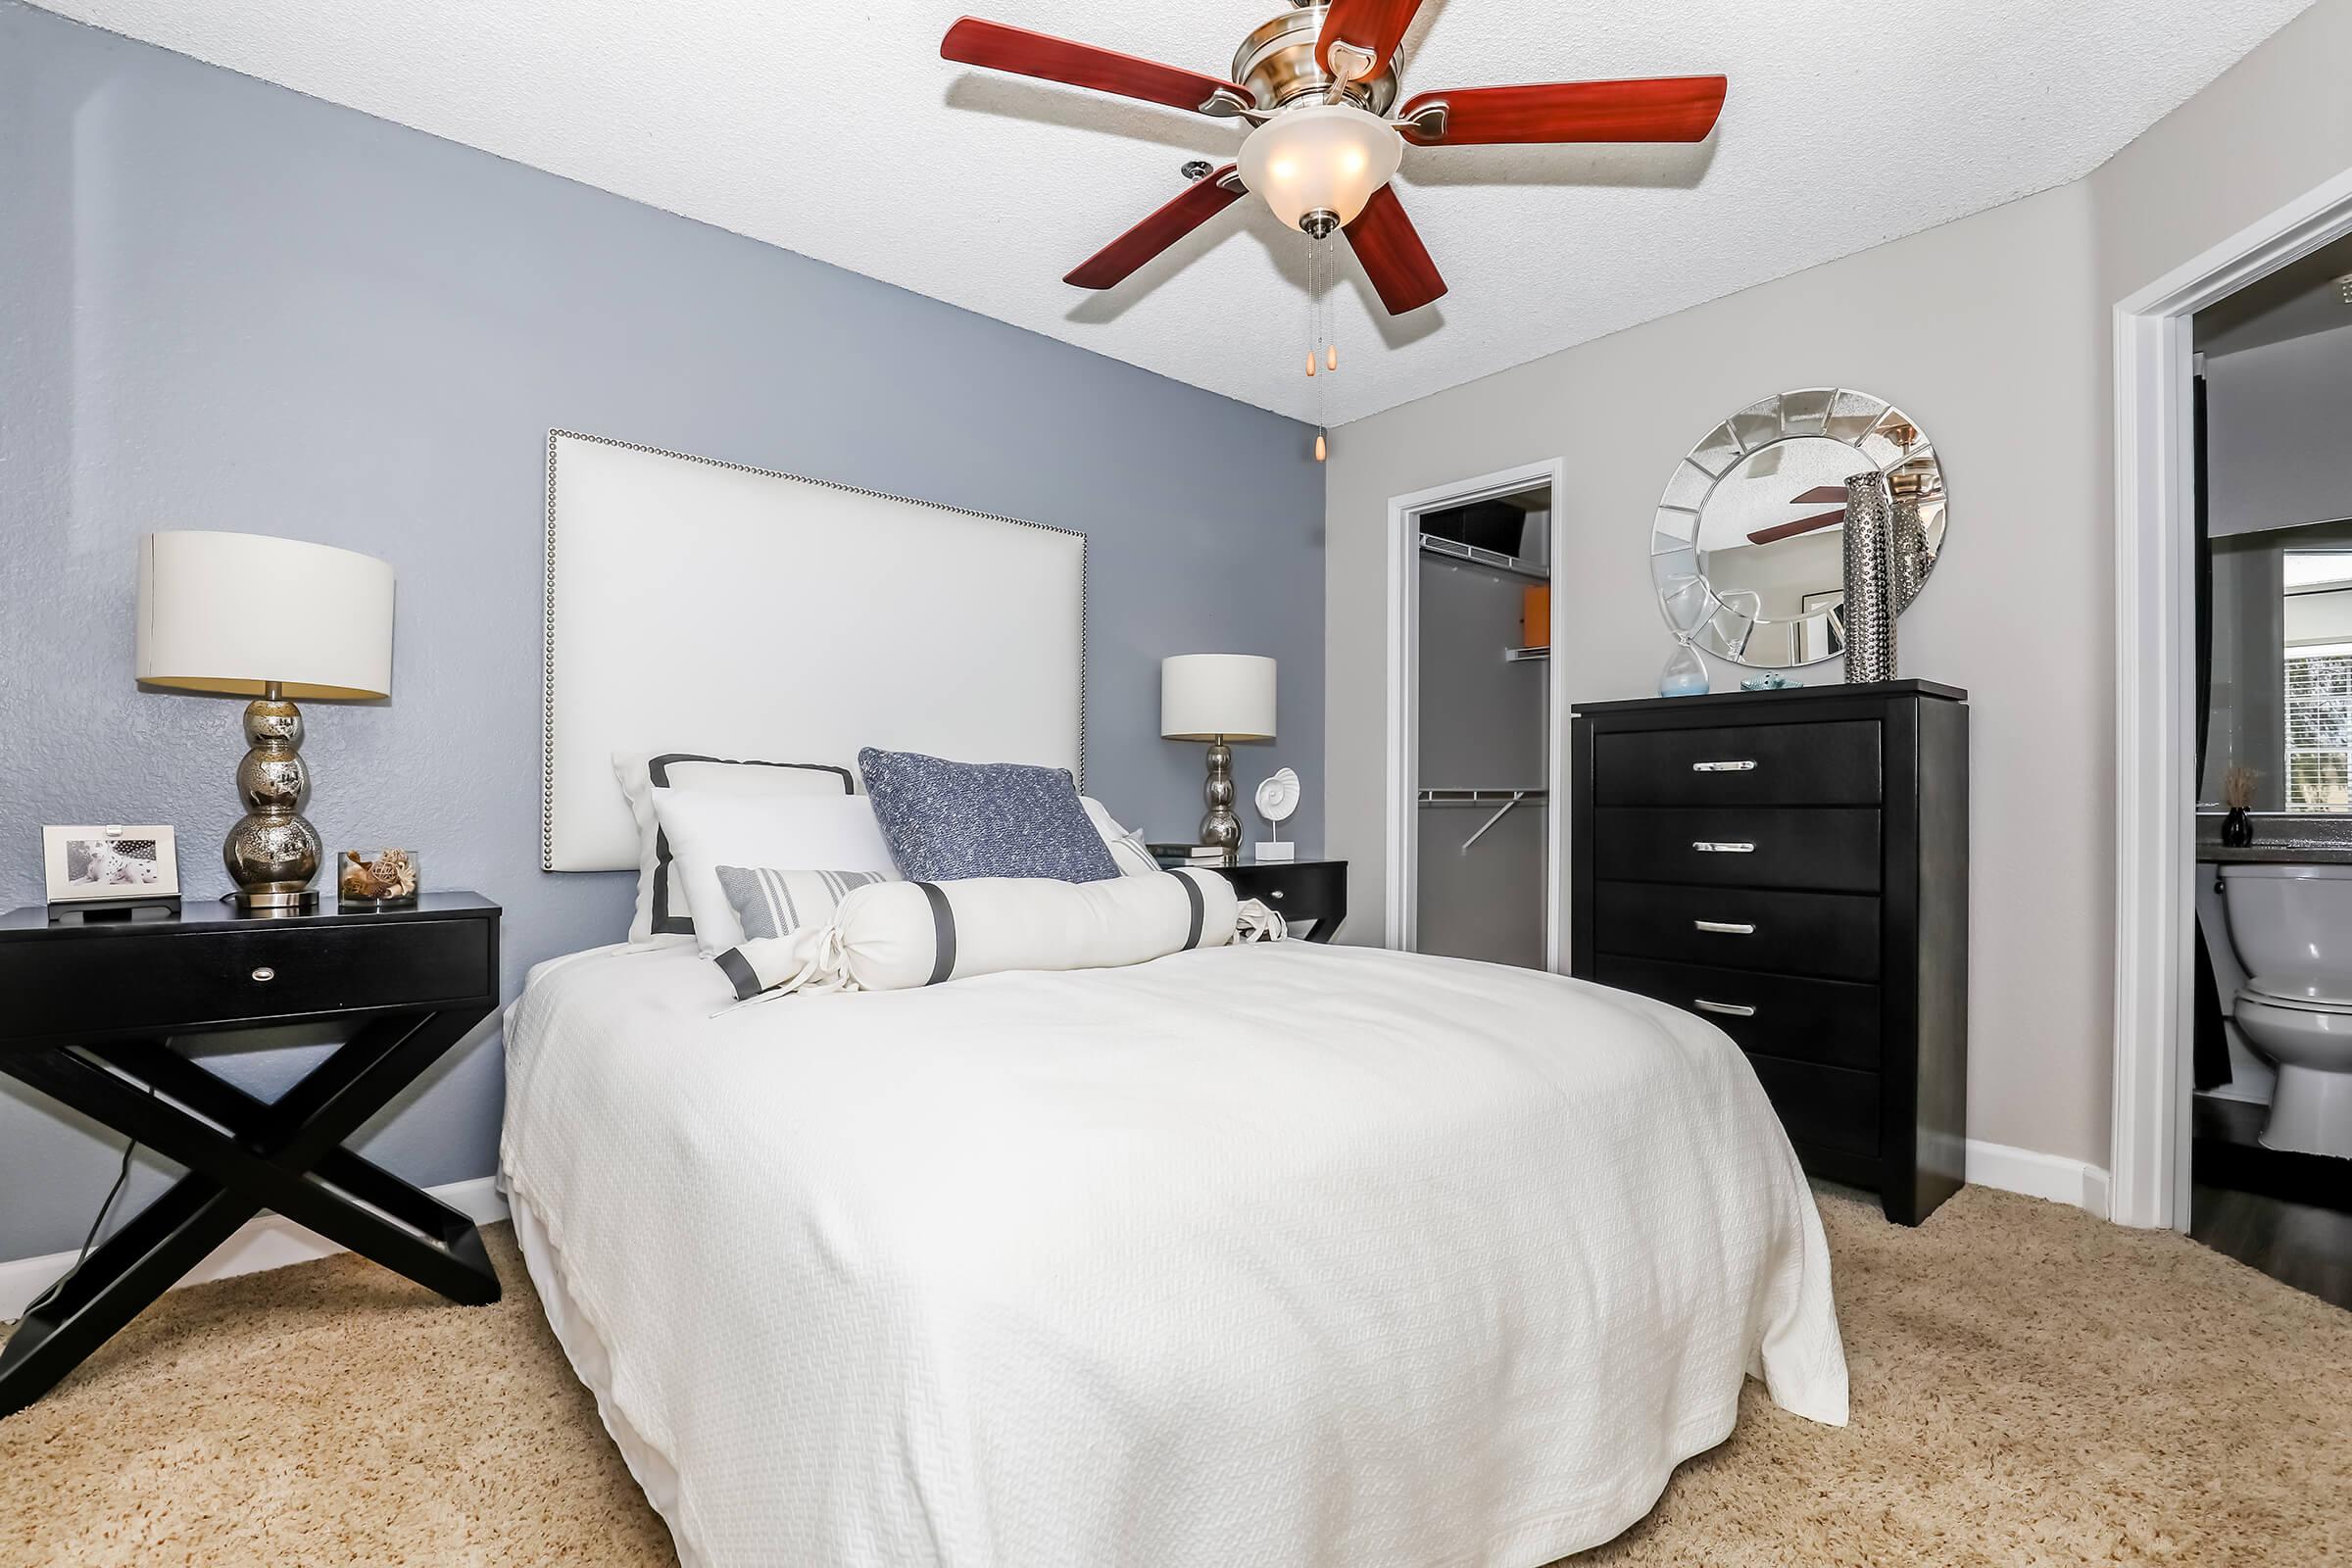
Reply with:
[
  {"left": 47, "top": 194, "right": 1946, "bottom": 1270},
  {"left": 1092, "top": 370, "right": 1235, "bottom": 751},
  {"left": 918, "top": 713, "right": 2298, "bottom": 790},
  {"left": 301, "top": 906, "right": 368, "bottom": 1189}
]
[{"left": 939, "top": 0, "right": 1724, "bottom": 315}]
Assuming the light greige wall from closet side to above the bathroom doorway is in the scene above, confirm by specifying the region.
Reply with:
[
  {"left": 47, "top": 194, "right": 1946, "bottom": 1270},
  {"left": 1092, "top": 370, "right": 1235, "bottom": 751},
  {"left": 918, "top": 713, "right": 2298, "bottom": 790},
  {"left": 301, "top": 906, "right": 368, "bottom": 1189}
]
[{"left": 1327, "top": 0, "right": 2352, "bottom": 1166}]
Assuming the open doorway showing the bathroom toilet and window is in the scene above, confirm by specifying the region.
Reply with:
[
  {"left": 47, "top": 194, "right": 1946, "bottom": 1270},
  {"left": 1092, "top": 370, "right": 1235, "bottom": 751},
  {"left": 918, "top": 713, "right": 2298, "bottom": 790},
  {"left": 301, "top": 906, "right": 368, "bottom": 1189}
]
[{"left": 2187, "top": 226, "right": 2352, "bottom": 1307}]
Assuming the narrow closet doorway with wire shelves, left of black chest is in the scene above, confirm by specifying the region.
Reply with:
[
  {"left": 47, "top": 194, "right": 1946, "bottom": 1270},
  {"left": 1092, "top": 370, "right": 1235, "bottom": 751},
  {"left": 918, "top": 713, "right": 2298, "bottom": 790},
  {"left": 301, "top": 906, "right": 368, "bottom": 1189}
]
[{"left": 1388, "top": 461, "right": 1566, "bottom": 971}]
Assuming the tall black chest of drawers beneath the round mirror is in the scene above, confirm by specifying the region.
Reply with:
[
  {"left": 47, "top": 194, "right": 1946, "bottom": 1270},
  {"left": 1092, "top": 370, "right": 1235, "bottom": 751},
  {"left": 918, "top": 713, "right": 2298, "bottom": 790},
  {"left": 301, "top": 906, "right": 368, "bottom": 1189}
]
[{"left": 1569, "top": 682, "right": 1969, "bottom": 1225}]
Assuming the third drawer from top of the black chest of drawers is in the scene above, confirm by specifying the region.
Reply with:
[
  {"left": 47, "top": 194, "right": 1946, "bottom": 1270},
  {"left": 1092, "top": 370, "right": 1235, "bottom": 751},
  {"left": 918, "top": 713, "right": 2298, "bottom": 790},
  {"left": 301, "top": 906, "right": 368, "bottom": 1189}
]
[{"left": 1592, "top": 882, "right": 1880, "bottom": 980}]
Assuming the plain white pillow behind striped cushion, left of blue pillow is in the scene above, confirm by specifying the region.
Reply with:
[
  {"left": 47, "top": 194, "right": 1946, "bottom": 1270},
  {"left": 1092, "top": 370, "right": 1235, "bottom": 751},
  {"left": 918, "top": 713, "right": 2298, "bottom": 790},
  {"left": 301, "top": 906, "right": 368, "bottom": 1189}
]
[{"left": 654, "top": 788, "right": 899, "bottom": 953}]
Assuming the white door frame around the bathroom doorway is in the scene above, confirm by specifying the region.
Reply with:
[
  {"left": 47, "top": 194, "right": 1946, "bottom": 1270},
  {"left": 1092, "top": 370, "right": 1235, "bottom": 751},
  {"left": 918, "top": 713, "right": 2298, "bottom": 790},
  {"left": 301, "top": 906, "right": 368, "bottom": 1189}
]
[{"left": 2110, "top": 174, "right": 2352, "bottom": 1230}]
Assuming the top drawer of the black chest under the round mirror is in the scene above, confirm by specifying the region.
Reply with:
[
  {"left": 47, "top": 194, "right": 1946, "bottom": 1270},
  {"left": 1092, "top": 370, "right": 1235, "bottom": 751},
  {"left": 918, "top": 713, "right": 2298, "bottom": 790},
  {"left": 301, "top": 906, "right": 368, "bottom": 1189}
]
[{"left": 1592, "top": 719, "right": 1882, "bottom": 807}]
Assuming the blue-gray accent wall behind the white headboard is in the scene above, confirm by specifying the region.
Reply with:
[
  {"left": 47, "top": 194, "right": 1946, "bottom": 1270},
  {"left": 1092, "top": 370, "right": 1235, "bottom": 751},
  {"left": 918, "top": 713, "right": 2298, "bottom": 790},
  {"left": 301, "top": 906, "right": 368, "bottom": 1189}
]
[{"left": 0, "top": 0, "right": 1324, "bottom": 1257}]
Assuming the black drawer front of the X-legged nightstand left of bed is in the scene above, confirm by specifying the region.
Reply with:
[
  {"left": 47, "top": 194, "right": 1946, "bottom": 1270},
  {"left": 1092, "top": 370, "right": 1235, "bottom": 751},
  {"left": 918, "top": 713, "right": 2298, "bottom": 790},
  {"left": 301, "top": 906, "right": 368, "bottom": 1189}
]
[{"left": 0, "top": 919, "right": 496, "bottom": 1039}]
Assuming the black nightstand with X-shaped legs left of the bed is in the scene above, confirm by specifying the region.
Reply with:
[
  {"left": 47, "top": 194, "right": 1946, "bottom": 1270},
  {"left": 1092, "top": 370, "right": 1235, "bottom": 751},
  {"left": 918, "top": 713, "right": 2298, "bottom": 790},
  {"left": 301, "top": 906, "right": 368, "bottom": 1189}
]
[{"left": 0, "top": 894, "right": 499, "bottom": 1415}]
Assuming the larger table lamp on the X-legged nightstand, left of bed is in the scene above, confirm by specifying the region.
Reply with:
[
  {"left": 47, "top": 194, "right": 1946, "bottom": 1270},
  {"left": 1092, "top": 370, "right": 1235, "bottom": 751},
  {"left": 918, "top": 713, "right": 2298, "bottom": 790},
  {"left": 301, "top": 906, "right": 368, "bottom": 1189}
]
[{"left": 136, "top": 531, "right": 393, "bottom": 912}]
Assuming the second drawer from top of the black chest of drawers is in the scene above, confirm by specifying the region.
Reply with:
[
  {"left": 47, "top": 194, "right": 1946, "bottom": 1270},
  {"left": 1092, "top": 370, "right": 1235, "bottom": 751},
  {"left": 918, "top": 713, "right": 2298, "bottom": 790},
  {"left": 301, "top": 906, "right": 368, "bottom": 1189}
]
[{"left": 1594, "top": 807, "right": 1880, "bottom": 894}]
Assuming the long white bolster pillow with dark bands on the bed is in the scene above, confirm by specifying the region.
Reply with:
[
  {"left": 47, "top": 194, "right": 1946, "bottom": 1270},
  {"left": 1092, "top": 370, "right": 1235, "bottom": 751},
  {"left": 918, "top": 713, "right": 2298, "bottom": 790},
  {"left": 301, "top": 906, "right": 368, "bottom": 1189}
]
[{"left": 717, "top": 867, "right": 1240, "bottom": 997}]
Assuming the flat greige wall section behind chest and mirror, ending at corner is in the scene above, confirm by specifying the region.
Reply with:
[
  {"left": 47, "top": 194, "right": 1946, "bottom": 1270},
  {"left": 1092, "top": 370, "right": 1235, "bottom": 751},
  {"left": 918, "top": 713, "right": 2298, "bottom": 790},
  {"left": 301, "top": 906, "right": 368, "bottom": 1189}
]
[{"left": 1327, "top": 186, "right": 2112, "bottom": 1163}]
